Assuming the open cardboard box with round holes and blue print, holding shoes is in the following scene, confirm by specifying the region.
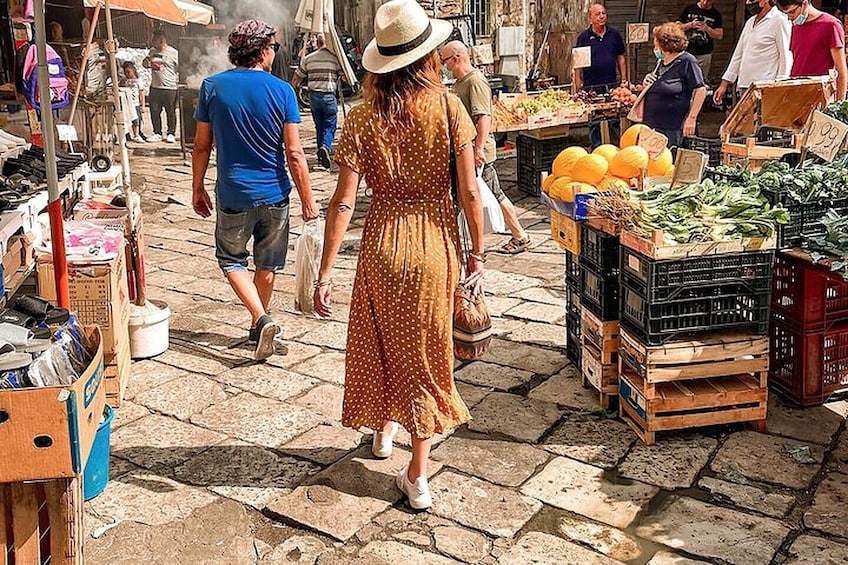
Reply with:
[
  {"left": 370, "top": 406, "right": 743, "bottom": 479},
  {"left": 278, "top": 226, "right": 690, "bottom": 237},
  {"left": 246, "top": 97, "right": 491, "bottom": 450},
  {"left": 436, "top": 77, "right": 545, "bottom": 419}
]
[{"left": 0, "top": 326, "right": 106, "bottom": 483}]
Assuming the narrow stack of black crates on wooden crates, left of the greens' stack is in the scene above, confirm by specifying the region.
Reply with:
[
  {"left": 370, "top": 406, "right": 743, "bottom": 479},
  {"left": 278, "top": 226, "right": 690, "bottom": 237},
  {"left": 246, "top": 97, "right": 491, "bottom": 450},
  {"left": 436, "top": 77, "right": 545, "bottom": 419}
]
[{"left": 580, "top": 220, "right": 619, "bottom": 409}]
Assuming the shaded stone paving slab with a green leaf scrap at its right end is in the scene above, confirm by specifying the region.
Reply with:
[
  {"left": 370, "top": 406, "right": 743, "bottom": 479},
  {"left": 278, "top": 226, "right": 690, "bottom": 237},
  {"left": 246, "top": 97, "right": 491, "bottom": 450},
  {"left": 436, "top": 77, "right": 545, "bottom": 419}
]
[{"left": 710, "top": 431, "right": 824, "bottom": 489}]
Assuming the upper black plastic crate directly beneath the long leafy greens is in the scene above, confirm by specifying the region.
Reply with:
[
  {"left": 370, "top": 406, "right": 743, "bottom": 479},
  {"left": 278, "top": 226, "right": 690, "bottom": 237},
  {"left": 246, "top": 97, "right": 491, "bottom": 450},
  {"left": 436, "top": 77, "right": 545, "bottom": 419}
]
[{"left": 621, "top": 247, "right": 774, "bottom": 304}]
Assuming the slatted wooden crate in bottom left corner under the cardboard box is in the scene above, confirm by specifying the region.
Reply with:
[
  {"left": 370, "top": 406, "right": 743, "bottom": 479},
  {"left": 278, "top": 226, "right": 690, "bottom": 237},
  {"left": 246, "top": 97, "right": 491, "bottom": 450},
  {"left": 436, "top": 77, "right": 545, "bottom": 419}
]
[{"left": 0, "top": 476, "right": 84, "bottom": 565}]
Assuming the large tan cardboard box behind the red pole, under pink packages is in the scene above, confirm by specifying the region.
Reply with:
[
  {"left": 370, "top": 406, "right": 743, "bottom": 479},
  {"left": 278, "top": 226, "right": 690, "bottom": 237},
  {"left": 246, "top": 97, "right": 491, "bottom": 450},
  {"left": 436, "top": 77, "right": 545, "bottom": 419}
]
[{"left": 37, "top": 243, "right": 130, "bottom": 357}]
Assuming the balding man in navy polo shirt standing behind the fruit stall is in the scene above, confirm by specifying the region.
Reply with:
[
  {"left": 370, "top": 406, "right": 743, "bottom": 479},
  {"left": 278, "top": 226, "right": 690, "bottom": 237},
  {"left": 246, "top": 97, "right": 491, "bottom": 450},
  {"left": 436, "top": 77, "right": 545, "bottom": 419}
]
[{"left": 574, "top": 4, "right": 627, "bottom": 147}]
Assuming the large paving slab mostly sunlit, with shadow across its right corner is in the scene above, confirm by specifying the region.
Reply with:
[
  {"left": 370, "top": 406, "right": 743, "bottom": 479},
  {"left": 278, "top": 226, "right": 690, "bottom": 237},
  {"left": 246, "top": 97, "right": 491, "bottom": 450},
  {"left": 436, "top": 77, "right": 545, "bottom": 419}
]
[{"left": 521, "top": 457, "right": 659, "bottom": 528}]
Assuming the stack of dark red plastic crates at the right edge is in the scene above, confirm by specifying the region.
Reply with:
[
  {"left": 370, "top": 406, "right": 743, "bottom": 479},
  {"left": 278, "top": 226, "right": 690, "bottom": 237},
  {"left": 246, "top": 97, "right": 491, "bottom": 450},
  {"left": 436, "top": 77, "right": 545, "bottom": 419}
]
[{"left": 769, "top": 250, "right": 848, "bottom": 406}]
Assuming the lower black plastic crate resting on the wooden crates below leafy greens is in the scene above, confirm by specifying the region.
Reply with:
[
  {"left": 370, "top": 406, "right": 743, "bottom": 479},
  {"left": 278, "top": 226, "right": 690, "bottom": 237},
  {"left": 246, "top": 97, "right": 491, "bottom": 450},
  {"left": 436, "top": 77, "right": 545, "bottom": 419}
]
[{"left": 621, "top": 277, "right": 770, "bottom": 345}]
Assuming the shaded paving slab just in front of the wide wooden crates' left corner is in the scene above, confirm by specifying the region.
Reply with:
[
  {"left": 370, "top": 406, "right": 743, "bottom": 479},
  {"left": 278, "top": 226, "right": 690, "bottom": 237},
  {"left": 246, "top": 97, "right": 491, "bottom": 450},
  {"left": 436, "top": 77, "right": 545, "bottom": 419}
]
[{"left": 619, "top": 434, "right": 718, "bottom": 490}]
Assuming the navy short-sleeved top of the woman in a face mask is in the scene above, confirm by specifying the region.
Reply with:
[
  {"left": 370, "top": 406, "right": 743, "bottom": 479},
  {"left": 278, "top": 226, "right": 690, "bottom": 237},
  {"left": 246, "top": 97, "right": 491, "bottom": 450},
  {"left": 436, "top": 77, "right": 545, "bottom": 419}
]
[{"left": 644, "top": 51, "right": 704, "bottom": 130}]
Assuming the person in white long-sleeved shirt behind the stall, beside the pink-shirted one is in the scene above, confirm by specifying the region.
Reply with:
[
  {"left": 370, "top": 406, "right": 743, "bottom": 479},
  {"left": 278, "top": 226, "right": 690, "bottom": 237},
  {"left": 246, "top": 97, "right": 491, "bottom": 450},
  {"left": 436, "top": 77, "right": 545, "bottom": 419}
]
[{"left": 713, "top": 0, "right": 792, "bottom": 105}]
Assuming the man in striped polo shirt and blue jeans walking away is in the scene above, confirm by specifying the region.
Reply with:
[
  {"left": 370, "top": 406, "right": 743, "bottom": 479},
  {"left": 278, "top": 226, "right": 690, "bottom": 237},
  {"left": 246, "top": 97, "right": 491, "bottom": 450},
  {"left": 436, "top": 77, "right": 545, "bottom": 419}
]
[{"left": 292, "top": 33, "right": 342, "bottom": 171}]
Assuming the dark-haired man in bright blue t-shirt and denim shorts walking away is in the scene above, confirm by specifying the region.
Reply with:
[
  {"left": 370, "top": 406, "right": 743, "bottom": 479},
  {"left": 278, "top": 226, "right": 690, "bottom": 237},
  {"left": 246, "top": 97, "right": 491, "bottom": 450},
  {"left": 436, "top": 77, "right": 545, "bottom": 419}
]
[{"left": 192, "top": 20, "right": 319, "bottom": 359}]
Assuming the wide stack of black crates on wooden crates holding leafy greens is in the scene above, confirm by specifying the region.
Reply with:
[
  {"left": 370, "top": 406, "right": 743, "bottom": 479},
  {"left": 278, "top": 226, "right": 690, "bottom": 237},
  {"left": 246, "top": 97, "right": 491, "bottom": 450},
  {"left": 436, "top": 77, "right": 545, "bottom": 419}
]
[{"left": 619, "top": 232, "right": 774, "bottom": 445}]
